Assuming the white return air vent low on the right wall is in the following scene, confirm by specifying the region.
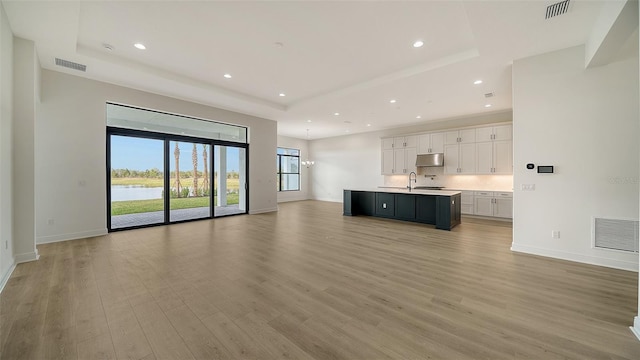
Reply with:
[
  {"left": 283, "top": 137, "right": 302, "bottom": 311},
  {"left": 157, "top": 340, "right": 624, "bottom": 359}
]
[{"left": 593, "top": 217, "right": 638, "bottom": 253}]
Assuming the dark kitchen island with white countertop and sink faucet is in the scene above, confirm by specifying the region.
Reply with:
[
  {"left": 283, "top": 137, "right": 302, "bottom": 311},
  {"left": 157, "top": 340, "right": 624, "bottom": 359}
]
[{"left": 343, "top": 188, "right": 461, "bottom": 230}]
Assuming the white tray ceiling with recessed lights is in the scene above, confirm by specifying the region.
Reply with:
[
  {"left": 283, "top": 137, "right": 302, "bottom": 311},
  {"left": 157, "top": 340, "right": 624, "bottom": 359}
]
[{"left": 2, "top": 0, "right": 624, "bottom": 139}]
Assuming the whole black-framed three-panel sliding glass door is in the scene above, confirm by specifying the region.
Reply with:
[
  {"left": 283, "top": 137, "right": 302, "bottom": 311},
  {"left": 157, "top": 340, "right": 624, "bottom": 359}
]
[{"left": 107, "top": 128, "right": 248, "bottom": 230}]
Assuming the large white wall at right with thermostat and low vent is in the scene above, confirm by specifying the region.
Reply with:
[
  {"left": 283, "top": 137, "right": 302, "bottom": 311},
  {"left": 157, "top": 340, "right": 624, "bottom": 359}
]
[{"left": 512, "top": 46, "right": 640, "bottom": 270}]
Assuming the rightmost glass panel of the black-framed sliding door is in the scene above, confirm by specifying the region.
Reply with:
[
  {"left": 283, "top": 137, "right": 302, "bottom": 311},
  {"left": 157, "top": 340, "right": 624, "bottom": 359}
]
[{"left": 213, "top": 145, "right": 247, "bottom": 216}]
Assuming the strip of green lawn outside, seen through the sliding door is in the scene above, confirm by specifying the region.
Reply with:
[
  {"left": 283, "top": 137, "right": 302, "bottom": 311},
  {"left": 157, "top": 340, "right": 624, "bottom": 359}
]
[{"left": 111, "top": 195, "right": 238, "bottom": 216}]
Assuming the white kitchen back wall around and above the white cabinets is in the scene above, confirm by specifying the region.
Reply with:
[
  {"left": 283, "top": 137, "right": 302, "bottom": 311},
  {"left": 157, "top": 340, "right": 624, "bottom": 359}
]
[{"left": 309, "top": 111, "right": 511, "bottom": 202}]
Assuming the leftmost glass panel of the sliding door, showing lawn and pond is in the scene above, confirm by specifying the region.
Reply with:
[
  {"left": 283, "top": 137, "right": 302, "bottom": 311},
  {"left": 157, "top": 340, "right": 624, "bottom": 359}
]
[{"left": 109, "top": 135, "right": 164, "bottom": 229}]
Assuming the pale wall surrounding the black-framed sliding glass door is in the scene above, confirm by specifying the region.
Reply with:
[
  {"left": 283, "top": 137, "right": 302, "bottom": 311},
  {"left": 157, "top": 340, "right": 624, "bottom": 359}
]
[{"left": 35, "top": 70, "right": 277, "bottom": 243}]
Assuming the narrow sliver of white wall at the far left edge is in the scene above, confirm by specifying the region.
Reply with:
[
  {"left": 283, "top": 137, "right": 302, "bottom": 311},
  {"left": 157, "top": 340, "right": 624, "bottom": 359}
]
[{"left": 0, "top": 4, "right": 15, "bottom": 291}]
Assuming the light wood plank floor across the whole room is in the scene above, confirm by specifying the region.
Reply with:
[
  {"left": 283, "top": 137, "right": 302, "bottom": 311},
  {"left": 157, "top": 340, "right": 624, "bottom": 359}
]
[{"left": 0, "top": 201, "right": 640, "bottom": 359}]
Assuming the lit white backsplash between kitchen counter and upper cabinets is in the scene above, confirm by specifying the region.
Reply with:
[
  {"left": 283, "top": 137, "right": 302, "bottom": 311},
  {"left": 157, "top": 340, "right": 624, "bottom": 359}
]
[{"left": 384, "top": 167, "right": 513, "bottom": 191}]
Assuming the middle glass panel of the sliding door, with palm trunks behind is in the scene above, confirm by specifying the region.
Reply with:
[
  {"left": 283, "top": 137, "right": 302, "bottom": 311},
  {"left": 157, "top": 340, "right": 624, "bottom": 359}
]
[{"left": 169, "top": 141, "right": 211, "bottom": 222}]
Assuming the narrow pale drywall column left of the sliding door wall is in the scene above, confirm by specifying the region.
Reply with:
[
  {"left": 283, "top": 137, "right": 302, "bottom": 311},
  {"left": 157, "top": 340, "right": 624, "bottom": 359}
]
[{"left": 13, "top": 38, "right": 39, "bottom": 263}]
